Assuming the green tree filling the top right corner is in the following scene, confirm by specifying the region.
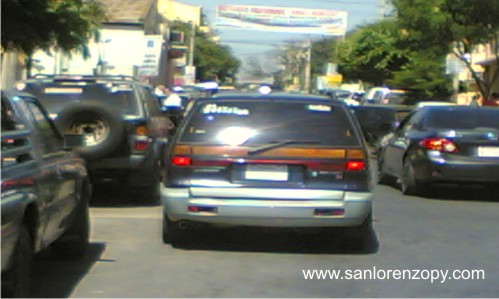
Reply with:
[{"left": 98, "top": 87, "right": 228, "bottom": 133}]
[{"left": 392, "top": 0, "right": 499, "bottom": 96}]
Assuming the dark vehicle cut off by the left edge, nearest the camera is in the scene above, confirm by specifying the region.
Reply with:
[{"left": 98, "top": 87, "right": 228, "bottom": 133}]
[{"left": 1, "top": 92, "right": 92, "bottom": 297}]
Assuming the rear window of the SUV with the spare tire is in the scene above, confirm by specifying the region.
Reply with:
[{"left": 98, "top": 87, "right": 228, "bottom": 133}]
[{"left": 21, "top": 83, "right": 138, "bottom": 115}]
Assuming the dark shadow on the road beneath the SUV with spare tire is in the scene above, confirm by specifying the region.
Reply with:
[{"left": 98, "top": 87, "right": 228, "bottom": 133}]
[{"left": 90, "top": 184, "right": 160, "bottom": 207}]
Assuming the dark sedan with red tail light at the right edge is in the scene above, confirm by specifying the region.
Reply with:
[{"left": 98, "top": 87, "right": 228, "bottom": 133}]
[{"left": 379, "top": 106, "right": 499, "bottom": 194}]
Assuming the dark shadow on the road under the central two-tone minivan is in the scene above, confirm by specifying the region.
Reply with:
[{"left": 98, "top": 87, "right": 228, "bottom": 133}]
[{"left": 168, "top": 228, "right": 380, "bottom": 254}]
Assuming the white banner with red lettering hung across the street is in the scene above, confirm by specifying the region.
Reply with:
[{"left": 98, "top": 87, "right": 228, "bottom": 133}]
[{"left": 215, "top": 5, "right": 348, "bottom": 36}]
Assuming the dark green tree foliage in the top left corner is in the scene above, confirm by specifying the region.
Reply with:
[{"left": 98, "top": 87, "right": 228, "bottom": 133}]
[{"left": 2, "top": 0, "right": 104, "bottom": 56}]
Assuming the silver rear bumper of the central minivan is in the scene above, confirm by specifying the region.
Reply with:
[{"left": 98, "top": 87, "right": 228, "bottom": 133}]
[{"left": 160, "top": 185, "right": 373, "bottom": 227}]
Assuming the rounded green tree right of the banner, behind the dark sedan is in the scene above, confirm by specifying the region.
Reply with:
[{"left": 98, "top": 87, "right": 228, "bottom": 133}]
[{"left": 338, "top": 19, "right": 451, "bottom": 98}]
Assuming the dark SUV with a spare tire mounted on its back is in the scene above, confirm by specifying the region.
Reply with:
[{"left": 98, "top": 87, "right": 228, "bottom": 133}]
[{"left": 16, "top": 75, "right": 174, "bottom": 201}]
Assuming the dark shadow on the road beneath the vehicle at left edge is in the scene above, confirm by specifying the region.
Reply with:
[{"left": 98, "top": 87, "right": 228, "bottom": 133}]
[{"left": 31, "top": 242, "right": 106, "bottom": 298}]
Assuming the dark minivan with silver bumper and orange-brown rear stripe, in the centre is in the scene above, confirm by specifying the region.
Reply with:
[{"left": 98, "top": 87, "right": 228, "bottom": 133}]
[{"left": 161, "top": 94, "right": 373, "bottom": 247}]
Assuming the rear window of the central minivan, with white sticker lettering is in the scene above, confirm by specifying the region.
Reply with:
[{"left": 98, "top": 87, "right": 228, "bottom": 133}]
[{"left": 181, "top": 100, "right": 359, "bottom": 146}]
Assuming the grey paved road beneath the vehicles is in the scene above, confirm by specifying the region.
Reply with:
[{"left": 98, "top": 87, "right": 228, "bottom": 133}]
[{"left": 34, "top": 186, "right": 499, "bottom": 298}]
